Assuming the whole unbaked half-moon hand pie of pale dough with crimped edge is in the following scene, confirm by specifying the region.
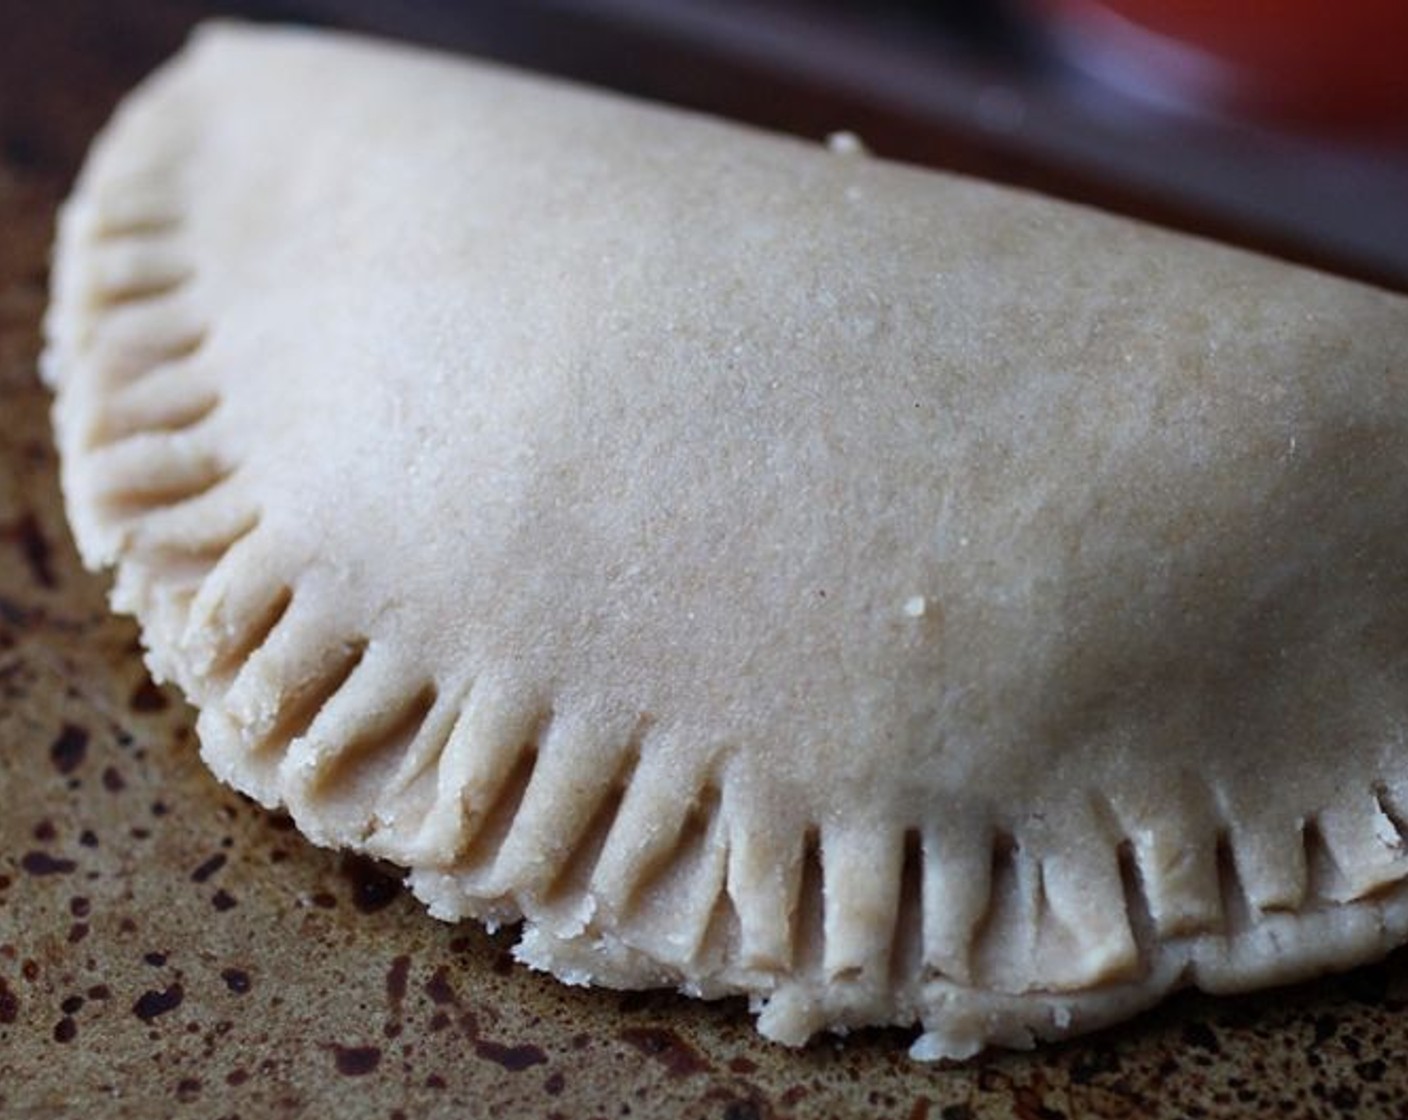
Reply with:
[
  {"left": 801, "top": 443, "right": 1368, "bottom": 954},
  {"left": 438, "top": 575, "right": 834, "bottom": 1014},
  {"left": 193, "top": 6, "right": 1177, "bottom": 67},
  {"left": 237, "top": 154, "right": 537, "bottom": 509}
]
[{"left": 45, "top": 25, "right": 1408, "bottom": 1057}]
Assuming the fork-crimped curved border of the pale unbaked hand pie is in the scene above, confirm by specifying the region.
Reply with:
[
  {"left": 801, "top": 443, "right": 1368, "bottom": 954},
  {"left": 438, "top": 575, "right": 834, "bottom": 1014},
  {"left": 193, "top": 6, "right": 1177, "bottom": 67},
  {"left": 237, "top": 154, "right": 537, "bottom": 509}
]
[{"left": 45, "top": 24, "right": 1408, "bottom": 1058}]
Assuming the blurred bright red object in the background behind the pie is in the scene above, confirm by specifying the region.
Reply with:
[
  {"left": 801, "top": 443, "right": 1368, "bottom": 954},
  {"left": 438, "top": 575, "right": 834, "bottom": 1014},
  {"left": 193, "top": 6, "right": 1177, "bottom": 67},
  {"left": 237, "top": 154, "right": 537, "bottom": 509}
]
[{"left": 1033, "top": 0, "right": 1408, "bottom": 138}]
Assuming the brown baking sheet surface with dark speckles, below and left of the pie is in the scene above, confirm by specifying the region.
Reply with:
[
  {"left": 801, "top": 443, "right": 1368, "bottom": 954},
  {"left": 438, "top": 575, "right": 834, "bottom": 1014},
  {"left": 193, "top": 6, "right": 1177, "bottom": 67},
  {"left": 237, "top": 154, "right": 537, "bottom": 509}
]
[{"left": 0, "top": 0, "right": 1408, "bottom": 1120}]
